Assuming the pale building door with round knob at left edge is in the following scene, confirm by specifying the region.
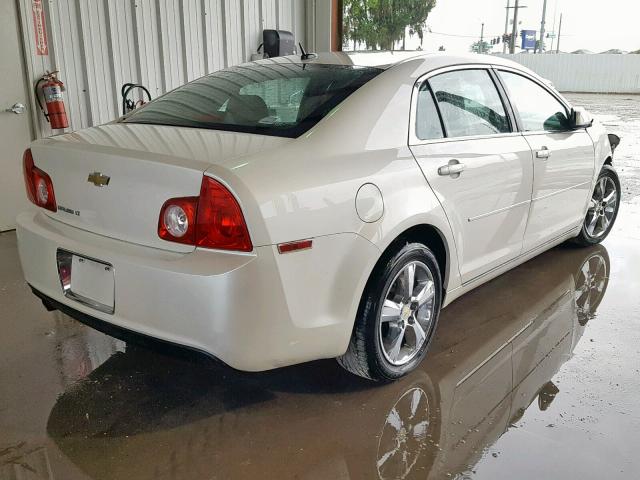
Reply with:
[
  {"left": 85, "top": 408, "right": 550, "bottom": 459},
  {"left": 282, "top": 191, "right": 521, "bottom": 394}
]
[{"left": 0, "top": 0, "right": 31, "bottom": 231}]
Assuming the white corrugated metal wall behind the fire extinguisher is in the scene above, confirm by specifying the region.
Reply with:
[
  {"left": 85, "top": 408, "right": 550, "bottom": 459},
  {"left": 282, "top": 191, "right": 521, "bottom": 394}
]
[{"left": 18, "top": 0, "right": 307, "bottom": 136}]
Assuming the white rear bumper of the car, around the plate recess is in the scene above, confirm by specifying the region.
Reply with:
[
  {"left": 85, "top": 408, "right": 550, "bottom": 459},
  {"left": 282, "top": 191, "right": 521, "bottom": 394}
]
[{"left": 17, "top": 212, "right": 377, "bottom": 371}]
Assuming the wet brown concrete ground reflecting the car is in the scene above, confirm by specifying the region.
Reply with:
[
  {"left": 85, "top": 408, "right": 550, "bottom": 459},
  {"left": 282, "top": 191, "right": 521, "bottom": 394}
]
[{"left": 0, "top": 94, "right": 640, "bottom": 480}]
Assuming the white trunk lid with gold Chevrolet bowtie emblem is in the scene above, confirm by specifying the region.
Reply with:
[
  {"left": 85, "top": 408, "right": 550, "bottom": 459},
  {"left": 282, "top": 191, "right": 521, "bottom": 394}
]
[{"left": 31, "top": 124, "right": 290, "bottom": 252}]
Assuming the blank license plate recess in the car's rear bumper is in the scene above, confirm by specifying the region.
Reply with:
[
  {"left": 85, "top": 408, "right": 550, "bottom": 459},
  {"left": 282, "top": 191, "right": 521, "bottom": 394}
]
[{"left": 56, "top": 249, "right": 115, "bottom": 314}]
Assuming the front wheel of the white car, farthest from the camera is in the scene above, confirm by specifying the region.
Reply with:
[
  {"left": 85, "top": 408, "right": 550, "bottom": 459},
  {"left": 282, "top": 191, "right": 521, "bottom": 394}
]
[{"left": 571, "top": 165, "right": 622, "bottom": 247}]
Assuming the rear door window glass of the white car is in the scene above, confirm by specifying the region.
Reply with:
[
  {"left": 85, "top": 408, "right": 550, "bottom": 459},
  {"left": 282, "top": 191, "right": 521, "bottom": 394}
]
[{"left": 429, "top": 70, "right": 511, "bottom": 137}]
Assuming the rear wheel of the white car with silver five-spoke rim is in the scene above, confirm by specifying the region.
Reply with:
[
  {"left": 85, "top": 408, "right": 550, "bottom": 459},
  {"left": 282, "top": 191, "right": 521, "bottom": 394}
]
[{"left": 337, "top": 243, "right": 442, "bottom": 382}]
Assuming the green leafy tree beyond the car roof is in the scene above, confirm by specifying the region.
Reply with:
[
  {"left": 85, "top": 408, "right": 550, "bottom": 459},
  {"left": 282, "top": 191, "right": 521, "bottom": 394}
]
[{"left": 342, "top": 0, "right": 436, "bottom": 50}]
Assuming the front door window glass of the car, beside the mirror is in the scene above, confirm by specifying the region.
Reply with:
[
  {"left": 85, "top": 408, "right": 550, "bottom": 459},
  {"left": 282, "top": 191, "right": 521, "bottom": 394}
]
[{"left": 500, "top": 72, "right": 569, "bottom": 131}]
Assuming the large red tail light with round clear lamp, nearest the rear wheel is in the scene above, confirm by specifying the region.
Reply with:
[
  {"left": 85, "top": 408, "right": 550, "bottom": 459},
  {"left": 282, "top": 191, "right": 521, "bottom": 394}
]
[{"left": 158, "top": 175, "right": 253, "bottom": 252}]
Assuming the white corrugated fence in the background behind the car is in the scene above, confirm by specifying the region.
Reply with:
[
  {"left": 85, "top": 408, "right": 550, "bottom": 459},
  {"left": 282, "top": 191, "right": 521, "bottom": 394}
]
[{"left": 500, "top": 53, "right": 640, "bottom": 93}]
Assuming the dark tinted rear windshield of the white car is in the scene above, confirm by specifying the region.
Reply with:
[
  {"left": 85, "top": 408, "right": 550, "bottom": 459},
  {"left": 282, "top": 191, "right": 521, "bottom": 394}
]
[{"left": 123, "top": 63, "right": 382, "bottom": 137}]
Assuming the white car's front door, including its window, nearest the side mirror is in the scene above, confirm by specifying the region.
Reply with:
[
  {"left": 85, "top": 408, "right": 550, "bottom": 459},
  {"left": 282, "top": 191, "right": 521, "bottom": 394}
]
[{"left": 498, "top": 68, "right": 595, "bottom": 251}]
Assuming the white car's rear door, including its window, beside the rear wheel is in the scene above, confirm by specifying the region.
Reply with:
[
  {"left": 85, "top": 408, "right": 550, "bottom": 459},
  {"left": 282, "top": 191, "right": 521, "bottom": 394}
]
[{"left": 410, "top": 66, "right": 533, "bottom": 283}]
